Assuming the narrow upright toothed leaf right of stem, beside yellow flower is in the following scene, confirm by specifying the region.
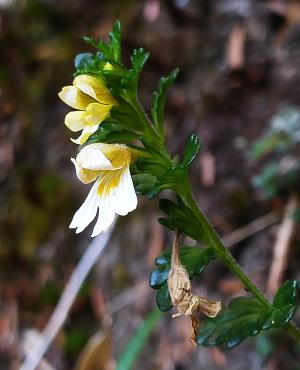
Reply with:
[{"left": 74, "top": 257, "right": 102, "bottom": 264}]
[{"left": 151, "top": 68, "right": 179, "bottom": 130}]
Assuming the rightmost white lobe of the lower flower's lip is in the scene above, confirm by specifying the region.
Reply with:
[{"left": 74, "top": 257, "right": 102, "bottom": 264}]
[{"left": 112, "top": 167, "right": 138, "bottom": 216}]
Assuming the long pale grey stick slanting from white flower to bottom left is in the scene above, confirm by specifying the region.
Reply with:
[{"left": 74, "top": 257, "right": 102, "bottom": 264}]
[{"left": 19, "top": 225, "right": 114, "bottom": 370}]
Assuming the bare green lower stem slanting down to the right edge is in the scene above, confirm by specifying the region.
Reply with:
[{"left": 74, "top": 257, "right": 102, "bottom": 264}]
[{"left": 181, "top": 192, "right": 300, "bottom": 341}]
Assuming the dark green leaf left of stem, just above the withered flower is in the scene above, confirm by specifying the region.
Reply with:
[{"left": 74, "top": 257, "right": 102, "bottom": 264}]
[{"left": 158, "top": 199, "right": 207, "bottom": 243}]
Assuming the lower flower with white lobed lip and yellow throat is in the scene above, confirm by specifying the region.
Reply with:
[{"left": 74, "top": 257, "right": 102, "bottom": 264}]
[{"left": 70, "top": 143, "right": 137, "bottom": 237}]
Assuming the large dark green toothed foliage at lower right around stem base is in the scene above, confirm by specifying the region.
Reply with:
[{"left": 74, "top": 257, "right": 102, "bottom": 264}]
[{"left": 197, "top": 280, "right": 297, "bottom": 348}]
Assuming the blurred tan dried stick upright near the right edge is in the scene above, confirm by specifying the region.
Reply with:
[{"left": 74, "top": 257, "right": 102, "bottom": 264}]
[{"left": 267, "top": 194, "right": 298, "bottom": 295}]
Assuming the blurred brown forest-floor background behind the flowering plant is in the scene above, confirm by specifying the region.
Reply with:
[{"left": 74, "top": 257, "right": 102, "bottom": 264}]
[{"left": 0, "top": 0, "right": 300, "bottom": 370}]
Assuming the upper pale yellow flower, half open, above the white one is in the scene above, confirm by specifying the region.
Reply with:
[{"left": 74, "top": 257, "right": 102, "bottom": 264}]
[{"left": 58, "top": 75, "right": 117, "bottom": 145}]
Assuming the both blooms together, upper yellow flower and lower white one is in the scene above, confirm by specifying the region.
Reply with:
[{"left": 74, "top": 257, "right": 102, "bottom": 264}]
[{"left": 59, "top": 75, "right": 137, "bottom": 236}]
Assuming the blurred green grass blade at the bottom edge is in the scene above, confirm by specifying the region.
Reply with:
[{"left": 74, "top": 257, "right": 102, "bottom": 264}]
[{"left": 116, "top": 309, "right": 161, "bottom": 370}]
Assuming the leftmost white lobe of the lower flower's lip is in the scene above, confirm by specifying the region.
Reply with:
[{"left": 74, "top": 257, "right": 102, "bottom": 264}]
[{"left": 69, "top": 181, "right": 100, "bottom": 234}]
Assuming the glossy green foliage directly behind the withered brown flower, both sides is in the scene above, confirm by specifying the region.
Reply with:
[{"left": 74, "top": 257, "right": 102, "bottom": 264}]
[{"left": 149, "top": 247, "right": 216, "bottom": 311}]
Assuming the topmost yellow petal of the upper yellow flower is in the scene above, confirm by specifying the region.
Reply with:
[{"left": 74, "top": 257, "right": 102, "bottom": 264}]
[{"left": 73, "top": 75, "right": 117, "bottom": 104}]
